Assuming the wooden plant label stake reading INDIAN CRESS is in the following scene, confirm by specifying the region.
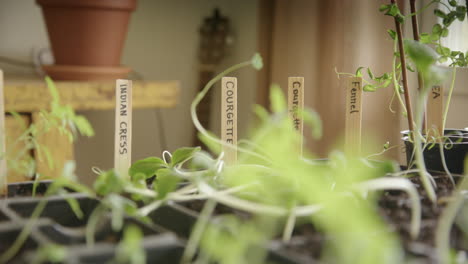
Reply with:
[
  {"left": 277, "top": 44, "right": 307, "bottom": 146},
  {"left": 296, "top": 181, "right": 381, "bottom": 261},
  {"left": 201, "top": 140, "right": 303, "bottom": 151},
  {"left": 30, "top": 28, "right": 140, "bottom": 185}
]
[{"left": 114, "top": 79, "right": 132, "bottom": 177}]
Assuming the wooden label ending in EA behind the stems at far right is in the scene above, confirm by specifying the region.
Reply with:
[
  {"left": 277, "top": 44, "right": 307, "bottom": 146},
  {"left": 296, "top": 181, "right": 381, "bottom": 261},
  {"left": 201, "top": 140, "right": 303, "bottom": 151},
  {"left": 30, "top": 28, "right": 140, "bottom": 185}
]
[{"left": 426, "top": 85, "right": 444, "bottom": 137}]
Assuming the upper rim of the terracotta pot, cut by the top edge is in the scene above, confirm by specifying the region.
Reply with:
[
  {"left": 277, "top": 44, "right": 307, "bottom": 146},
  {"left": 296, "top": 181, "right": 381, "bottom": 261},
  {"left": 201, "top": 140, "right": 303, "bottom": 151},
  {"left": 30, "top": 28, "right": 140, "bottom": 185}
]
[{"left": 36, "top": 0, "right": 137, "bottom": 12}]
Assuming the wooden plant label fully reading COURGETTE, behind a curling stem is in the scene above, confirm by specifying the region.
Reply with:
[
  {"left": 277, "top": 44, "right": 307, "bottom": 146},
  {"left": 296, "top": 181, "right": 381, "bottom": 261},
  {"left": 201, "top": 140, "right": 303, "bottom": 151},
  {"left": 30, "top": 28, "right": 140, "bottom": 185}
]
[{"left": 221, "top": 77, "right": 237, "bottom": 164}]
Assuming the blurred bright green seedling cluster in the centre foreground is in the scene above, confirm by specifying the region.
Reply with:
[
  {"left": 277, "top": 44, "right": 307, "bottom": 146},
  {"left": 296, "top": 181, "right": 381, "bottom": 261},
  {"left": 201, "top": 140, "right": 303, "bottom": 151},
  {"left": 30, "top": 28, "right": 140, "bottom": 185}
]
[{"left": 125, "top": 54, "right": 420, "bottom": 263}]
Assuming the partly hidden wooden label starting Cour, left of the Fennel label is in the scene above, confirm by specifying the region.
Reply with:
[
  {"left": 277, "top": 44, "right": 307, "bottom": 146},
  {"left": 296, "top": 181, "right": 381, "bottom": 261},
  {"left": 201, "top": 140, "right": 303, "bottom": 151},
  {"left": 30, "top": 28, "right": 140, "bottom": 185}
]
[{"left": 288, "top": 77, "right": 304, "bottom": 155}]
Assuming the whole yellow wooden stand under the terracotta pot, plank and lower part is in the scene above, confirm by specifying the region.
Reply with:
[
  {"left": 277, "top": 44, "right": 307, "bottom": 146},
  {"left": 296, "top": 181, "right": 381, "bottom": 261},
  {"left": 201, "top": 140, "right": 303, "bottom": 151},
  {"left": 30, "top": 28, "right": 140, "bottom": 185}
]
[{"left": 4, "top": 74, "right": 180, "bottom": 182}]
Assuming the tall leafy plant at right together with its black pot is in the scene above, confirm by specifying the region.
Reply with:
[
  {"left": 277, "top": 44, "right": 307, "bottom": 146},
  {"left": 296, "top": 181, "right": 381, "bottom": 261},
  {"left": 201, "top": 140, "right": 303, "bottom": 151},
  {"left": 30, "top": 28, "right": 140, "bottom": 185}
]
[{"left": 338, "top": 0, "right": 468, "bottom": 201}]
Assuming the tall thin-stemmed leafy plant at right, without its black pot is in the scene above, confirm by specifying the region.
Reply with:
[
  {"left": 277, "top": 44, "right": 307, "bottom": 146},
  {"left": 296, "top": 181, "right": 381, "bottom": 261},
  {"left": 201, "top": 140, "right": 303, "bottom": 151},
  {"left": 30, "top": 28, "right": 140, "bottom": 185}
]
[{"left": 338, "top": 0, "right": 468, "bottom": 202}]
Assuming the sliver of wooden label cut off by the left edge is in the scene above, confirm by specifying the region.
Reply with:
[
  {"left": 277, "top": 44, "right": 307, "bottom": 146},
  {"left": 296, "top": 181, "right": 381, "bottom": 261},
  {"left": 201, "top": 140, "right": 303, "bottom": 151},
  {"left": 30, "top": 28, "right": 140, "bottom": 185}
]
[{"left": 0, "top": 70, "right": 7, "bottom": 195}]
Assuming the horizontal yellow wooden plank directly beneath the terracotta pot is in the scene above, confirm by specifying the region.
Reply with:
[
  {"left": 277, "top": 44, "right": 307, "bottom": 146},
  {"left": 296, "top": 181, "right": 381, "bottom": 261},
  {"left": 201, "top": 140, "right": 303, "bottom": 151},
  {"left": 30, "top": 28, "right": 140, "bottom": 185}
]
[{"left": 5, "top": 75, "right": 180, "bottom": 112}]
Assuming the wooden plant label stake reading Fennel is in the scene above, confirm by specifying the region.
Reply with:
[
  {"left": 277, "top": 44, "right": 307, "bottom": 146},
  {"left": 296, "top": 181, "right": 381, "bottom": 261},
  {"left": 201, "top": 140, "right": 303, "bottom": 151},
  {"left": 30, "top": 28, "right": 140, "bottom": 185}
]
[{"left": 345, "top": 77, "right": 362, "bottom": 155}]
